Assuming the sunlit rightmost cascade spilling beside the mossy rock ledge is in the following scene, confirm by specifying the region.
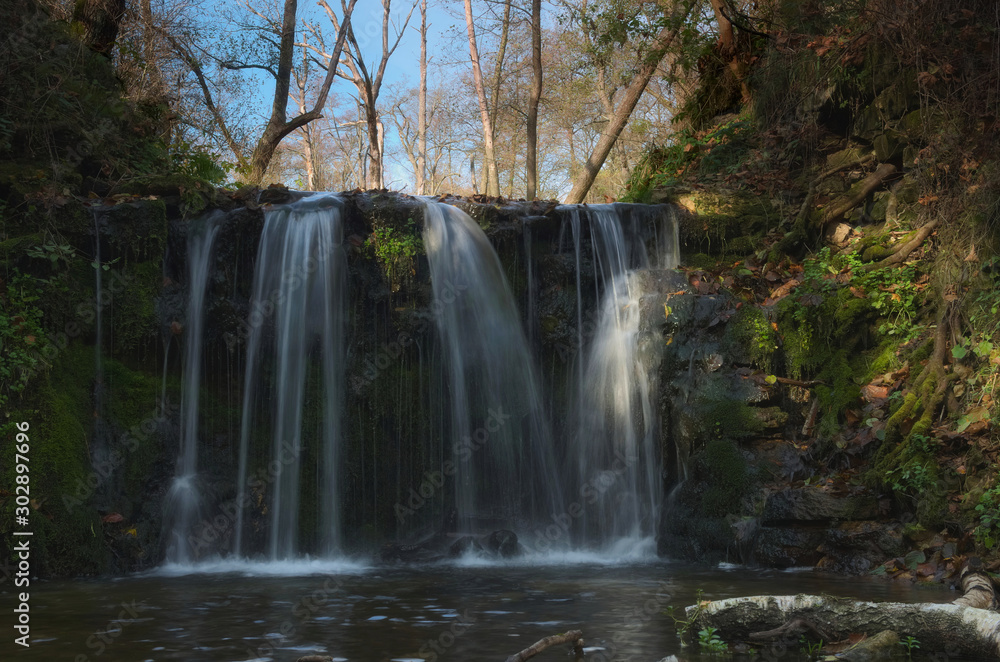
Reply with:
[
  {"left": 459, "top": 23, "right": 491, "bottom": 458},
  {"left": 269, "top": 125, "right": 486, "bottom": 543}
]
[{"left": 570, "top": 205, "right": 678, "bottom": 546}]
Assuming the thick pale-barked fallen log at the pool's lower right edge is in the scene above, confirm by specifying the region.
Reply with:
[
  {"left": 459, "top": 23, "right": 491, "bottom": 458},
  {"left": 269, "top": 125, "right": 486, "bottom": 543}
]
[{"left": 685, "top": 595, "right": 1000, "bottom": 660}]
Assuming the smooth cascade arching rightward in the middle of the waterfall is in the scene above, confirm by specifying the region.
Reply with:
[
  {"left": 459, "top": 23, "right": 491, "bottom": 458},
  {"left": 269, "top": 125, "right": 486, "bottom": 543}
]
[{"left": 424, "top": 202, "right": 563, "bottom": 532}]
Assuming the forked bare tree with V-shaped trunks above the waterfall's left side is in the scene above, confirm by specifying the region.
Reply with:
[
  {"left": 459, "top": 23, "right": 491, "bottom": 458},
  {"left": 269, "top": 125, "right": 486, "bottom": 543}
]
[{"left": 166, "top": 0, "right": 357, "bottom": 186}]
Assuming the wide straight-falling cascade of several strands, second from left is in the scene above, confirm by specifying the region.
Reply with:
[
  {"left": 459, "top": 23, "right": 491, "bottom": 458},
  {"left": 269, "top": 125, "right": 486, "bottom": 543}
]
[{"left": 234, "top": 194, "right": 347, "bottom": 560}]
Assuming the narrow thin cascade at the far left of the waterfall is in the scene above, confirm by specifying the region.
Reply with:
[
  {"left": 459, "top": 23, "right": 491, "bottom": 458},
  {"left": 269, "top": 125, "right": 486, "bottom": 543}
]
[{"left": 167, "top": 212, "right": 222, "bottom": 563}]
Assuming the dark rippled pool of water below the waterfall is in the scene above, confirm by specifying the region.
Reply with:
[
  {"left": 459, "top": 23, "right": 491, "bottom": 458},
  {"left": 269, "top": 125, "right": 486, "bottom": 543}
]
[{"left": 9, "top": 558, "right": 954, "bottom": 662}]
